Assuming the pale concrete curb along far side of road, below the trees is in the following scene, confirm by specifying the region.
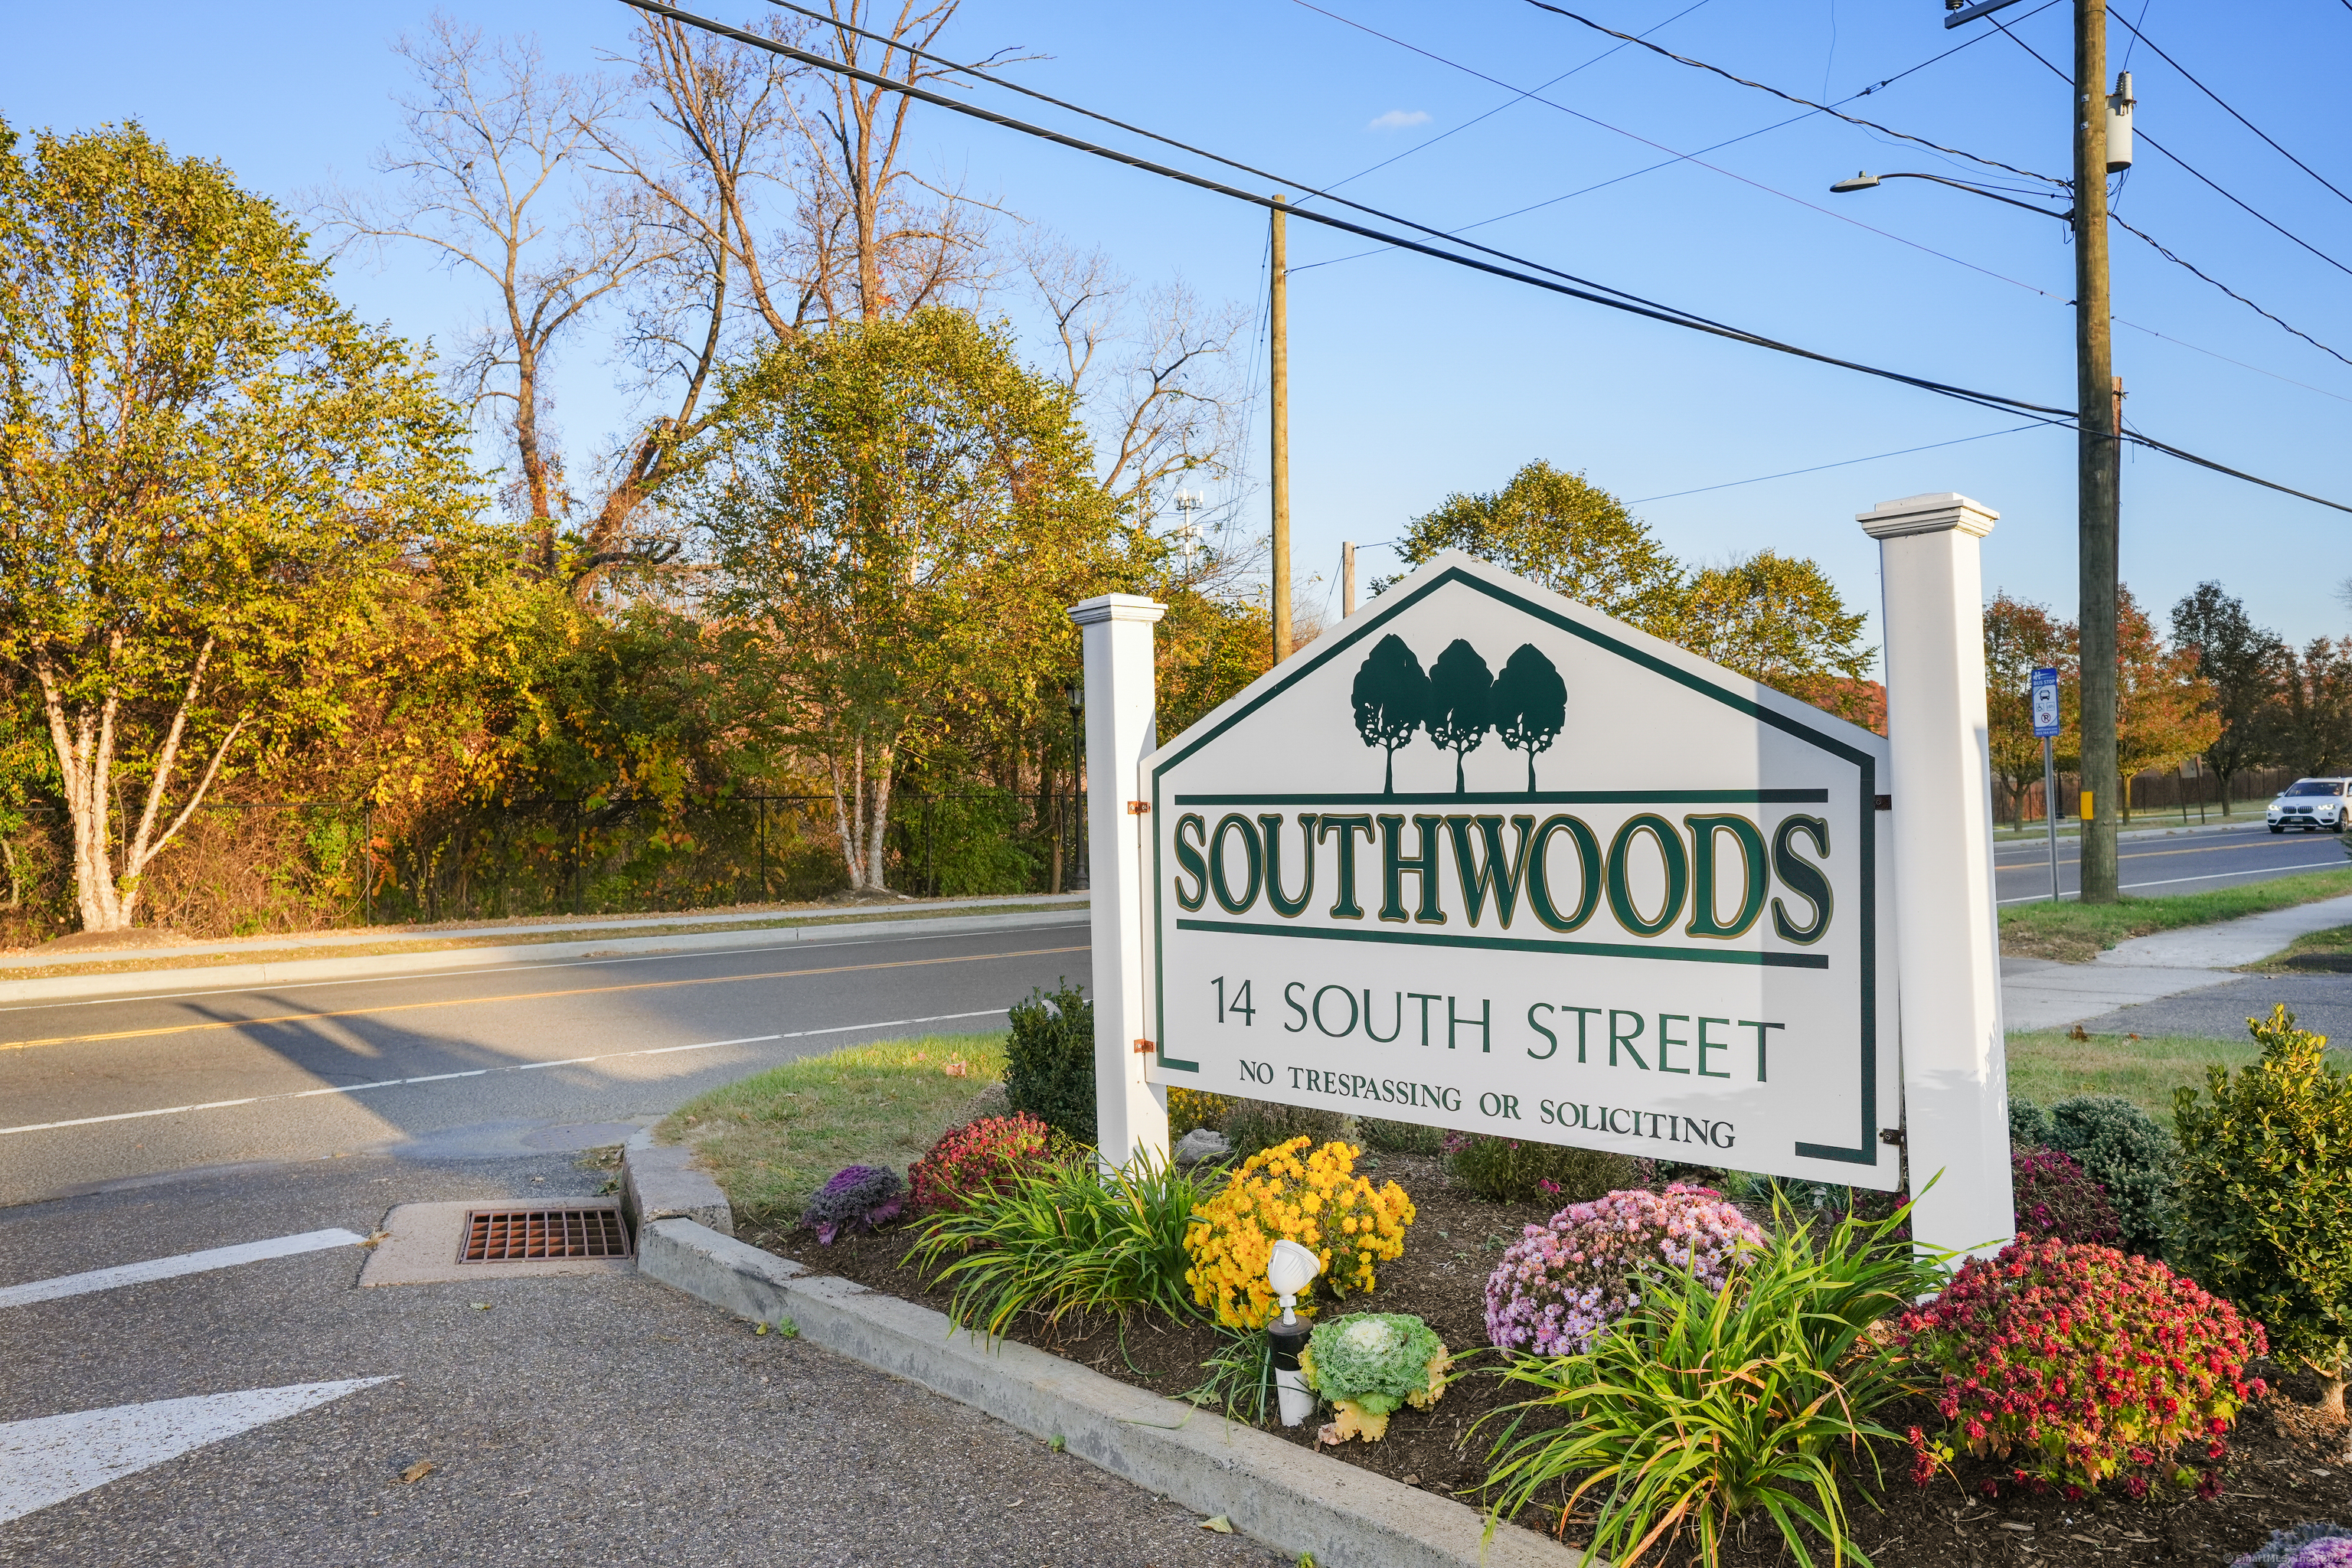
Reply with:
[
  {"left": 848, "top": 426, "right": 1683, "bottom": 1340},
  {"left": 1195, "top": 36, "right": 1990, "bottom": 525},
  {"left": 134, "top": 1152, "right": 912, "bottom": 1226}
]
[{"left": 0, "top": 910, "right": 1091, "bottom": 1004}]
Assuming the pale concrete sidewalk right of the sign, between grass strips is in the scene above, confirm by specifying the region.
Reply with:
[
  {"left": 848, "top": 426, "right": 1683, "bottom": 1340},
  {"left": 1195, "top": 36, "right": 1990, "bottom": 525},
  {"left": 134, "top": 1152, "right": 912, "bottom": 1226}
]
[{"left": 2001, "top": 898, "right": 2352, "bottom": 1030}]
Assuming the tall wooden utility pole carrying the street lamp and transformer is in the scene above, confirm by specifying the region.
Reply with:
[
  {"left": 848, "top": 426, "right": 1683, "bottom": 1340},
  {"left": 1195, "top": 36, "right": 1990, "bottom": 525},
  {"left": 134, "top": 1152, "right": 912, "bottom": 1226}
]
[{"left": 2075, "top": 0, "right": 2124, "bottom": 903}]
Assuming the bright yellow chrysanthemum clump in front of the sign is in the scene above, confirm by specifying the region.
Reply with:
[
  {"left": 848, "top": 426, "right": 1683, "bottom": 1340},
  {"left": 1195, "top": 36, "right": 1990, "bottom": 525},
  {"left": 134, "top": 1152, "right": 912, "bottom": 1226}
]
[{"left": 1185, "top": 1138, "right": 1413, "bottom": 1328}]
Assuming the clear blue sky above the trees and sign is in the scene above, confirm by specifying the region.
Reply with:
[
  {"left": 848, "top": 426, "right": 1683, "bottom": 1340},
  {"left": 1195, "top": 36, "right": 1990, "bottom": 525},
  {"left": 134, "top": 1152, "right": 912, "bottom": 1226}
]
[{"left": 0, "top": 0, "right": 2352, "bottom": 662}]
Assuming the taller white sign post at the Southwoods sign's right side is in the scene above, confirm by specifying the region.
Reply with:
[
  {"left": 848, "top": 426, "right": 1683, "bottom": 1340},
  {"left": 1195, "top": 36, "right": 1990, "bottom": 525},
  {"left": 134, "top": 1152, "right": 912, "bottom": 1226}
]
[{"left": 1858, "top": 494, "right": 2016, "bottom": 1250}]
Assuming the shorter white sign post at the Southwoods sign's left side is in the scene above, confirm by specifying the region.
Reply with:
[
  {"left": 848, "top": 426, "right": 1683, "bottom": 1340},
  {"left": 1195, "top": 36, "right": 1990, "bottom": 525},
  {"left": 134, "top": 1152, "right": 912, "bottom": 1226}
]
[{"left": 1070, "top": 593, "right": 1169, "bottom": 1168}]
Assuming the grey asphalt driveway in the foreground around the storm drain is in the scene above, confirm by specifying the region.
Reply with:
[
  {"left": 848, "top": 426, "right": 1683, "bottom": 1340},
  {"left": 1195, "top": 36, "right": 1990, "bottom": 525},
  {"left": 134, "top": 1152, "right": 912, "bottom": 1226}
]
[{"left": 0, "top": 1147, "right": 1286, "bottom": 1568}]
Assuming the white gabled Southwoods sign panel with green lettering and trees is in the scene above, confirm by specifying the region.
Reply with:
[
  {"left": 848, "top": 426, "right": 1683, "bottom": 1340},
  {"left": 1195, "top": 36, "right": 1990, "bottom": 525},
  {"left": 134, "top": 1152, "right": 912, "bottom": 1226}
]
[{"left": 1138, "top": 555, "right": 1900, "bottom": 1190}]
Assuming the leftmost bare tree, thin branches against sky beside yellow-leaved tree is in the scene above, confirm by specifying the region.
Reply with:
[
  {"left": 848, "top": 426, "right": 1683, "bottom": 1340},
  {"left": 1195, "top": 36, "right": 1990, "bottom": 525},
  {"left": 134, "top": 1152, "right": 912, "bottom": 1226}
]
[{"left": 318, "top": 11, "right": 663, "bottom": 571}]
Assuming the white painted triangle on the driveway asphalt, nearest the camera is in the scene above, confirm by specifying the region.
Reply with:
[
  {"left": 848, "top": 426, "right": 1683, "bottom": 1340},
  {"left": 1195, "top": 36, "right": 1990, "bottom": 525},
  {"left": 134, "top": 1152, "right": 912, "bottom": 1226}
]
[{"left": 0, "top": 1377, "right": 390, "bottom": 1521}]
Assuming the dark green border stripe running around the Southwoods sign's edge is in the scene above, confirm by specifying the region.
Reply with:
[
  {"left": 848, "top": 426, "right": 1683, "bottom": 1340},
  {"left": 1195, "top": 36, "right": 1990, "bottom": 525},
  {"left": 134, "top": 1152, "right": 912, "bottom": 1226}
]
[{"left": 1152, "top": 567, "right": 1880, "bottom": 1168}]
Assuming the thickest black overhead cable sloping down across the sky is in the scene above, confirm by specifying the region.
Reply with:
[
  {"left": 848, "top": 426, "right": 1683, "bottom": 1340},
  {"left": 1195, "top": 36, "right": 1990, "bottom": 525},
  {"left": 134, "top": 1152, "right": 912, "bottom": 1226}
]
[{"left": 623, "top": 0, "right": 2352, "bottom": 512}]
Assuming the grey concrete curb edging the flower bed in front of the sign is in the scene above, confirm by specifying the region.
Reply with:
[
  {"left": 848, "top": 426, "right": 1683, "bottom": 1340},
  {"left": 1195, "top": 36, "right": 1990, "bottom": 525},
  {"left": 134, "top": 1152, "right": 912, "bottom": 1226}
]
[{"left": 630, "top": 1213, "right": 1580, "bottom": 1568}]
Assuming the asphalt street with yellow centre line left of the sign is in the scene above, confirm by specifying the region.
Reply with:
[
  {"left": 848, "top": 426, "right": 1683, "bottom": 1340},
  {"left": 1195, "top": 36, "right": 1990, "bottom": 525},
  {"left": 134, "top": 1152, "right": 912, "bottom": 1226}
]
[{"left": 0, "top": 914, "right": 1089, "bottom": 1213}]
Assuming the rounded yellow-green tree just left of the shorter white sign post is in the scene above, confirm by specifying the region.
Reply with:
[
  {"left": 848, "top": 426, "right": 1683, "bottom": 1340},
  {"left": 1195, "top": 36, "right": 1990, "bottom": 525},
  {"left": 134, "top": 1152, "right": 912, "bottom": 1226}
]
[{"left": 689, "top": 308, "right": 1126, "bottom": 889}]
